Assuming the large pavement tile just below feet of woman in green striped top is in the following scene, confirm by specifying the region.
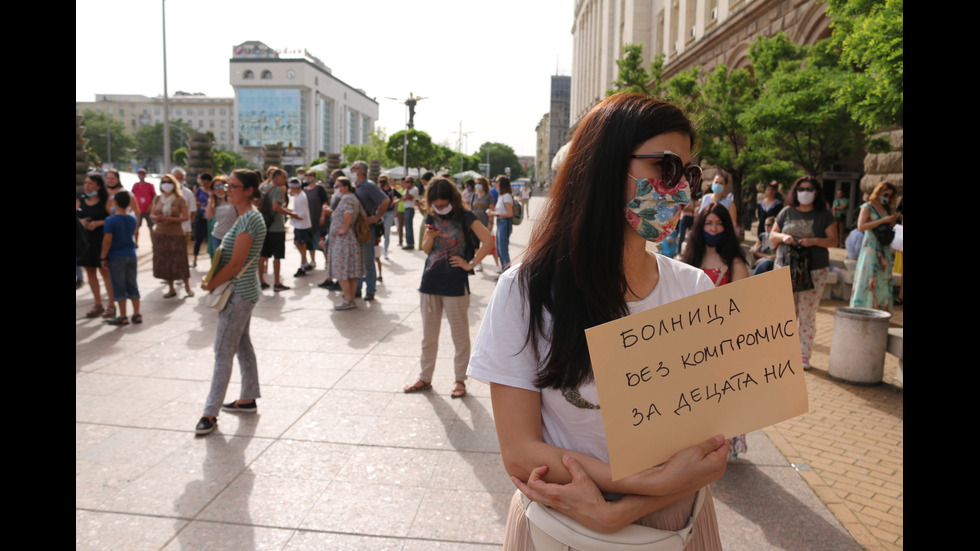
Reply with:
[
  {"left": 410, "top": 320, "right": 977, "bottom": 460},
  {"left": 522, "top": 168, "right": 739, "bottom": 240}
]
[{"left": 100, "top": 432, "right": 272, "bottom": 519}]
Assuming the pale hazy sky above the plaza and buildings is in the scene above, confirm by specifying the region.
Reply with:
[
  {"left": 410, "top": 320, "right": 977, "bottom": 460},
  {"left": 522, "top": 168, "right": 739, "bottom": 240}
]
[{"left": 75, "top": 0, "right": 574, "bottom": 160}]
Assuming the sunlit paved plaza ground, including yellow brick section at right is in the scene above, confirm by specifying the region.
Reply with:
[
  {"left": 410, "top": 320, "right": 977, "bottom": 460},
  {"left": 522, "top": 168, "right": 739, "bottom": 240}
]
[{"left": 75, "top": 197, "right": 904, "bottom": 551}]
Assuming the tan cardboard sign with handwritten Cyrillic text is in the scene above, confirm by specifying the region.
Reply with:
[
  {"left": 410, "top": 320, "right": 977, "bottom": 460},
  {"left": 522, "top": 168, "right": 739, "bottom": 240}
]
[{"left": 585, "top": 268, "right": 809, "bottom": 480}]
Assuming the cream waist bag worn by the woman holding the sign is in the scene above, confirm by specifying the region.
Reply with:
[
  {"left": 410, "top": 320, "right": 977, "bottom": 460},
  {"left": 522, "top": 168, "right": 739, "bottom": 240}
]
[{"left": 521, "top": 486, "right": 708, "bottom": 551}]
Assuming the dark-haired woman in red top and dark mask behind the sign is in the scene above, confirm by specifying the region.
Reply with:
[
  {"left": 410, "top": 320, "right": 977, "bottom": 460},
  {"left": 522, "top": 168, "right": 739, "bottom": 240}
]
[{"left": 683, "top": 203, "right": 749, "bottom": 463}]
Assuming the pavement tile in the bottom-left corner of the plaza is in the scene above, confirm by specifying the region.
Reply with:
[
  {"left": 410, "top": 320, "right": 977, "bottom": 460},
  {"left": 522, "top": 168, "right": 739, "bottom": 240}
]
[{"left": 75, "top": 509, "right": 187, "bottom": 551}]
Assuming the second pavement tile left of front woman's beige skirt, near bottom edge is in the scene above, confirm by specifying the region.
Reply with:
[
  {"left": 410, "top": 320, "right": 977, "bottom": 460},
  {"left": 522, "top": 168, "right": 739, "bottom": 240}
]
[{"left": 301, "top": 482, "right": 425, "bottom": 536}]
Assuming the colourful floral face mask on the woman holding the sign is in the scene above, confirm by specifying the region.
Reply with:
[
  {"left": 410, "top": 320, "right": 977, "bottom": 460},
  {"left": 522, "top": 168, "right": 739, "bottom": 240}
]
[{"left": 625, "top": 176, "right": 691, "bottom": 243}]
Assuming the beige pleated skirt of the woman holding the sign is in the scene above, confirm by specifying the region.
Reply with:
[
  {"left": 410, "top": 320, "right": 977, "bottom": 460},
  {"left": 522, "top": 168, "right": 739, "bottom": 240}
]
[{"left": 504, "top": 489, "right": 721, "bottom": 551}]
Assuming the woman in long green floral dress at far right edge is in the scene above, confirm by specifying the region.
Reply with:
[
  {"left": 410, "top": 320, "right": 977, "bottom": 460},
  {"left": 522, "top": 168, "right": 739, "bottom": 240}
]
[{"left": 851, "top": 180, "right": 898, "bottom": 312}]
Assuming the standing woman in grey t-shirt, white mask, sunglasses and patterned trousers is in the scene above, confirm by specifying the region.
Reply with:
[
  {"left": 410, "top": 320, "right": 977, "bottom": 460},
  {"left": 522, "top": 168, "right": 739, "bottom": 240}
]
[{"left": 769, "top": 176, "right": 837, "bottom": 369}]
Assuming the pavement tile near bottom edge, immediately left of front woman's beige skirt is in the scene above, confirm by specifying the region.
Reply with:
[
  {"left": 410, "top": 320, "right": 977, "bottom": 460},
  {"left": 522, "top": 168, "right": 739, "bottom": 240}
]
[{"left": 407, "top": 489, "right": 513, "bottom": 544}]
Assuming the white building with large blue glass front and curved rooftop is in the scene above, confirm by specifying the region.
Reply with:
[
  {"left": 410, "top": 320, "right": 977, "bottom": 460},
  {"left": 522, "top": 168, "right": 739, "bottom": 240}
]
[{"left": 229, "top": 41, "right": 378, "bottom": 165}]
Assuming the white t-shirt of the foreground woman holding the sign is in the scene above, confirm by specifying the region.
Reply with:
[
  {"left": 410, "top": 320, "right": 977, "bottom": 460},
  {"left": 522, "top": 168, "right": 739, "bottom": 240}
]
[{"left": 467, "top": 255, "right": 714, "bottom": 463}]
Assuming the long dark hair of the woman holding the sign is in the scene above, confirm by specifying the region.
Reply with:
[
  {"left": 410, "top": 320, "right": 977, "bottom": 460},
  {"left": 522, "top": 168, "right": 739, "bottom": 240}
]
[{"left": 518, "top": 94, "right": 697, "bottom": 389}]
